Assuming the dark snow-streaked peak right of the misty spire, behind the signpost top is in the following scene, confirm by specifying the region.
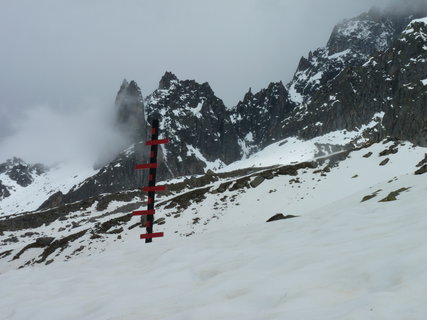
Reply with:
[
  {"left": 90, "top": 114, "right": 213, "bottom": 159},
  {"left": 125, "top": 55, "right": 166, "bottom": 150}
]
[{"left": 145, "top": 72, "right": 241, "bottom": 176}]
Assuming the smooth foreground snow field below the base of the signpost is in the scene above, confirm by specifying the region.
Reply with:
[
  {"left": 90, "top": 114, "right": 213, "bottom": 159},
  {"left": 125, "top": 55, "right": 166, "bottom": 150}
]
[{"left": 0, "top": 172, "right": 427, "bottom": 319}]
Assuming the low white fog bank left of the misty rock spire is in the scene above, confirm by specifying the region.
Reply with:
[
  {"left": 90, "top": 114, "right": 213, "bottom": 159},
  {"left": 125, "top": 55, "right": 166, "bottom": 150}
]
[{"left": 0, "top": 99, "right": 130, "bottom": 166}]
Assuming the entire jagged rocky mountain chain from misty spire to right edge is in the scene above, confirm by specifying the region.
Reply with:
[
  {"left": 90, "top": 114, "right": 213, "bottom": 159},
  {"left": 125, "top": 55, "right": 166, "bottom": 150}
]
[{"left": 1, "top": 10, "right": 427, "bottom": 214}]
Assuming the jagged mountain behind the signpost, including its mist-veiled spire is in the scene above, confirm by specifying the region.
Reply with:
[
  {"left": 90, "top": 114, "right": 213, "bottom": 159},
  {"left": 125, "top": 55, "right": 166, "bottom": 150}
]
[{"left": 40, "top": 72, "right": 241, "bottom": 209}]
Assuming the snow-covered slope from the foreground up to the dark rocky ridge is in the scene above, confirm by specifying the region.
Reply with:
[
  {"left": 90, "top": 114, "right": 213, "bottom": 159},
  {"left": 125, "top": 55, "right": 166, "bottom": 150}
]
[{"left": 0, "top": 142, "right": 427, "bottom": 320}]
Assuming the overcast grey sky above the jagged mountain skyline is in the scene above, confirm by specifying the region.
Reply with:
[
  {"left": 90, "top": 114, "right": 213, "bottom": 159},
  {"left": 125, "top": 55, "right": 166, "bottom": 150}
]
[{"left": 0, "top": 0, "right": 408, "bottom": 161}]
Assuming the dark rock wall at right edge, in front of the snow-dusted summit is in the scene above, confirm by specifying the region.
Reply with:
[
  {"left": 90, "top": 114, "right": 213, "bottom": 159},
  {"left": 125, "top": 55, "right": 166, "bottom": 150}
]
[{"left": 283, "top": 15, "right": 427, "bottom": 145}]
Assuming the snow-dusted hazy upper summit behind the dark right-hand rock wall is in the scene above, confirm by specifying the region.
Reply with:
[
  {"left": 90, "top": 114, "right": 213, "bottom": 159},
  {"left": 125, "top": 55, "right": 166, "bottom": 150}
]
[{"left": 288, "top": 9, "right": 427, "bottom": 103}]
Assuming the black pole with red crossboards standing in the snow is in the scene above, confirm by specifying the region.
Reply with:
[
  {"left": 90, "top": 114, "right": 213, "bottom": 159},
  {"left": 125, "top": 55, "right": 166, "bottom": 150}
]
[{"left": 132, "top": 120, "right": 169, "bottom": 243}]
